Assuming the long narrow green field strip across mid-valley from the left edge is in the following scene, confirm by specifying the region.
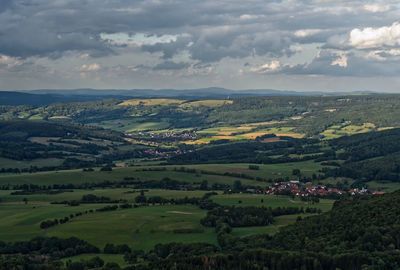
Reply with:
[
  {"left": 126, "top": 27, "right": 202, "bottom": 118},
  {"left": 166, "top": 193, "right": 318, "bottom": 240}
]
[{"left": 0, "top": 160, "right": 330, "bottom": 187}]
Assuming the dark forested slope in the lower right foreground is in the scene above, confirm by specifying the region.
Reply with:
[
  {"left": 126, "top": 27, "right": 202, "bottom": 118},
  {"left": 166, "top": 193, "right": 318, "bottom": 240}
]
[{"left": 145, "top": 192, "right": 400, "bottom": 269}]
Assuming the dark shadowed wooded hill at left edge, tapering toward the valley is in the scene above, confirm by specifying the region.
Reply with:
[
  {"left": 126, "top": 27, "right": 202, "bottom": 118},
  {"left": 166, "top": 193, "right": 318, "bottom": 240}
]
[{"left": 0, "top": 120, "right": 150, "bottom": 173}]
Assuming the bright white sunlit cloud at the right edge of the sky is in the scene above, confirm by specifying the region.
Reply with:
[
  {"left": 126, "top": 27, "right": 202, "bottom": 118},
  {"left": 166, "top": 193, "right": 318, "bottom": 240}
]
[{"left": 349, "top": 22, "right": 400, "bottom": 49}]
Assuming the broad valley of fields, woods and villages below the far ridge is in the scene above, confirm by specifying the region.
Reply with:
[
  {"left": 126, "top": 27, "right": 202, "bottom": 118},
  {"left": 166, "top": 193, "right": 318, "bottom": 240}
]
[{"left": 0, "top": 96, "right": 400, "bottom": 267}]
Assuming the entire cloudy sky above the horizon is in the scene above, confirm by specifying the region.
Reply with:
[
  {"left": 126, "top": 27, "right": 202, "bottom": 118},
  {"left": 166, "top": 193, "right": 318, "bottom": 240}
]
[{"left": 0, "top": 0, "right": 400, "bottom": 92}]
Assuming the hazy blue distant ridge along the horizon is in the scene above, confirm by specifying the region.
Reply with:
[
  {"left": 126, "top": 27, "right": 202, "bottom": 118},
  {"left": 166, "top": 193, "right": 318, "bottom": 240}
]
[{"left": 0, "top": 87, "right": 374, "bottom": 106}]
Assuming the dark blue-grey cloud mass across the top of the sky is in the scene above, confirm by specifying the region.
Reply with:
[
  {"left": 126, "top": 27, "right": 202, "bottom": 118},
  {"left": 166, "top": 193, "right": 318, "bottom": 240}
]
[{"left": 0, "top": 0, "right": 391, "bottom": 59}]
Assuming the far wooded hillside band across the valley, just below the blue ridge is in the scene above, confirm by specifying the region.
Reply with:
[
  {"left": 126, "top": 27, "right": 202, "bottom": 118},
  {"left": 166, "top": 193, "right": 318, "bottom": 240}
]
[{"left": 0, "top": 95, "right": 400, "bottom": 138}]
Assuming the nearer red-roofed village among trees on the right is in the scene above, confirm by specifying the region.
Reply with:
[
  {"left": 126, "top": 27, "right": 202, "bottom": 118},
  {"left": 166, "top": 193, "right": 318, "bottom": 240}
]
[{"left": 264, "top": 180, "right": 384, "bottom": 197}]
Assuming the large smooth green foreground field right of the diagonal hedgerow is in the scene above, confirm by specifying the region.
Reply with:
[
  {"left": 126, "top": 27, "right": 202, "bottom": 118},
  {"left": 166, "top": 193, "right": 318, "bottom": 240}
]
[{"left": 47, "top": 205, "right": 217, "bottom": 250}]
